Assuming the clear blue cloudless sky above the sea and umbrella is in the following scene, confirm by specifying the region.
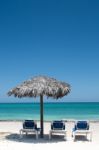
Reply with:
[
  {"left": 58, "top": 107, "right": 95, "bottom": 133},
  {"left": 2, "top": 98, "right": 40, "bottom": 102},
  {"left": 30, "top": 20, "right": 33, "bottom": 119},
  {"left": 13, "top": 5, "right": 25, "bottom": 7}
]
[{"left": 0, "top": 0, "right": 99, "bottom": 102}]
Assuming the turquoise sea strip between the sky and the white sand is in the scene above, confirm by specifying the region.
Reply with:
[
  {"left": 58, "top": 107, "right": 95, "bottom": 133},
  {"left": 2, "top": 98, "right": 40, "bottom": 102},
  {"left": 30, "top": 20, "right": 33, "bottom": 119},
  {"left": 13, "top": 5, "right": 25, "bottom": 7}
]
[{"left": 0, "top": 102, "right": 99, "bottom": 121}]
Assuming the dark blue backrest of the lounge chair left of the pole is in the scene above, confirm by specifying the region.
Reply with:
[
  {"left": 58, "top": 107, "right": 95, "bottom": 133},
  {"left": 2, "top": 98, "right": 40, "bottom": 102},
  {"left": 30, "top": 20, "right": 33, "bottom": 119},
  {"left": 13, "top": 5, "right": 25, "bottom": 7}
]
[{"left": 23, "top": 120, "right": 37, "bottom": 129}]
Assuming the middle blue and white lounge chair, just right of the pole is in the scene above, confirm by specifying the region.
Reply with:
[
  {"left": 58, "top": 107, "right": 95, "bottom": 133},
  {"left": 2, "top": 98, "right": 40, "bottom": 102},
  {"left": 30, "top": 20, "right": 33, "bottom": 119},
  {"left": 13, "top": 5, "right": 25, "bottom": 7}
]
[{"left": 49, "top": 121, "right": 66, "bottom": 140}]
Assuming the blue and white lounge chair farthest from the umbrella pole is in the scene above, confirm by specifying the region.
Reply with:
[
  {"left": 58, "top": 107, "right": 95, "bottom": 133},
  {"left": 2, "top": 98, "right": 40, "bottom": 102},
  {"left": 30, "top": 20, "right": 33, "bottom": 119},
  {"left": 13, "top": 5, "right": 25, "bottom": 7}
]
[{"left": 72, "top": 121, "right": 92, "bottom": 141}]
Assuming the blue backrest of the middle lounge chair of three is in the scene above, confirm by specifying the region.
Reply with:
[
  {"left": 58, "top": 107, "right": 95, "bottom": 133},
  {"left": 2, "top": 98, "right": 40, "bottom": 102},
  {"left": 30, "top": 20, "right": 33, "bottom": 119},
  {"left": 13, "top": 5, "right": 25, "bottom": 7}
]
[{"left": 51, "top": 121, "right": 65, "bottom": 130}]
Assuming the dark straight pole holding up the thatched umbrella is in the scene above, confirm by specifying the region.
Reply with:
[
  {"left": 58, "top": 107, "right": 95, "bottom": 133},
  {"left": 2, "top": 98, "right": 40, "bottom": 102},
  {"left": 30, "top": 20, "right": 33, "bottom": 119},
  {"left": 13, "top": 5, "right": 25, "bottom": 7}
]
[{"left": 40, "top": 95, "right": 44, "bottom": 138}]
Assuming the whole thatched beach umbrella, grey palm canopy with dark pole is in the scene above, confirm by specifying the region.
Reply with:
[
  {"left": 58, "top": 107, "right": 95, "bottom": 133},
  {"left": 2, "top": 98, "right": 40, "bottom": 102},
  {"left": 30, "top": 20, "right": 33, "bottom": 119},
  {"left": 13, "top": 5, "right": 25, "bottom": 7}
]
[{"left": 8, "top": 76, "right": 70, "bottom": 137}]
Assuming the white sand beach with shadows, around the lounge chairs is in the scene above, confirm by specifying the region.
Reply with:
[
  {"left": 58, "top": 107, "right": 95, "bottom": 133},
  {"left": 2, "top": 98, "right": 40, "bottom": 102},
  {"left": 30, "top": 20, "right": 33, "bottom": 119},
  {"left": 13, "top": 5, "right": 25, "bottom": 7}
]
[{"left": 0, "top": 121, "right": 99, "bottom": 150}]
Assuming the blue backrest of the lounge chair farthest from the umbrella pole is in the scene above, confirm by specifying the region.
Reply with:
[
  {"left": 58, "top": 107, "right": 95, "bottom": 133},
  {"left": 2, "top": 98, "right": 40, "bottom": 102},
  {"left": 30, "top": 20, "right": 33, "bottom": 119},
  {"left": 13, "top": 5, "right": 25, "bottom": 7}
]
[{"left": 75, "top": 121, "right": 89, "bottom": 130}]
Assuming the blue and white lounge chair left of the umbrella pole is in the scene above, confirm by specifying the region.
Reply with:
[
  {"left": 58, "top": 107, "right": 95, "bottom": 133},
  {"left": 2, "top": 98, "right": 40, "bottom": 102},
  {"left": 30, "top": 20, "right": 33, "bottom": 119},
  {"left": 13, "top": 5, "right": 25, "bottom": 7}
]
[{"left": 20, "top": 120, "right": 40, "bottom": 139}]
